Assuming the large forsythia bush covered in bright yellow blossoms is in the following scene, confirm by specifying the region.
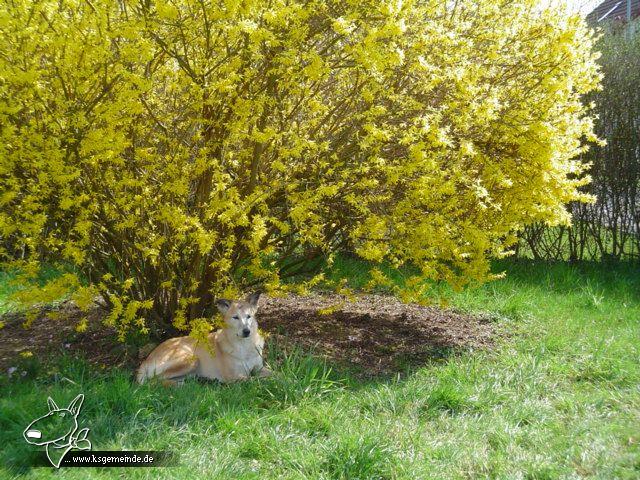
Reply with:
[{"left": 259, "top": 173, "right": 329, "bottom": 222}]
[{"left": 0, "top": 0, "right": 599, "bottom": 336}]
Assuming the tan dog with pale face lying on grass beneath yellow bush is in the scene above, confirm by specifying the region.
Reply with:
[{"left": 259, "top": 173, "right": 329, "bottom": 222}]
[{"left": 136, "top": 293, "right": 271, "bottom": 384}]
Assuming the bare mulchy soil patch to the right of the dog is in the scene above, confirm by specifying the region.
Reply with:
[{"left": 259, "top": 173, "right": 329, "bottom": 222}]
[{"left": 258, "top": 295, "right": 495, "bottom": 376}]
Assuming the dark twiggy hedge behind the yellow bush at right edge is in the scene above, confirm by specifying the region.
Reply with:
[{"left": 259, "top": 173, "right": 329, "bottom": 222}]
[{"left": 520, "top": 23, "right": 640, "bottom": 260}]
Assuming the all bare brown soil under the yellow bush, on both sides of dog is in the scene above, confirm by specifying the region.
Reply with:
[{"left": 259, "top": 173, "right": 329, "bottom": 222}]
[{"left": 0, "top": 294, "right": 495, "bottom": 376}]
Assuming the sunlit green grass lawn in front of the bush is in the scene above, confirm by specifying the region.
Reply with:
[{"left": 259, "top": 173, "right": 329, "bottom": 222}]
[{"left": 0, "top": 260, "right": 640, "bottom": 479}]
